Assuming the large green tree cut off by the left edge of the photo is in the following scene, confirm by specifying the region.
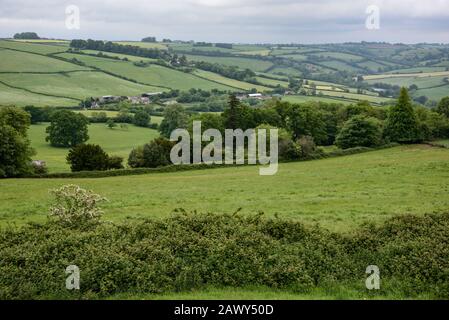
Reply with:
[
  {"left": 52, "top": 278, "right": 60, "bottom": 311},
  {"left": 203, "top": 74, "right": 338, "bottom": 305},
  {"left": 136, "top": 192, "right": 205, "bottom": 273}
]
[{"left": 0, "top": 107, "right": 34, "bottom": 177}]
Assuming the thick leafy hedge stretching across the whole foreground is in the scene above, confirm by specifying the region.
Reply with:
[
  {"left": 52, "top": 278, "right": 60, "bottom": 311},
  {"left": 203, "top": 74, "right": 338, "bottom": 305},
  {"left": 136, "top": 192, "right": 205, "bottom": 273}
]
[{"left": 0, "top": 213, "right": 449, "bottom": 299}]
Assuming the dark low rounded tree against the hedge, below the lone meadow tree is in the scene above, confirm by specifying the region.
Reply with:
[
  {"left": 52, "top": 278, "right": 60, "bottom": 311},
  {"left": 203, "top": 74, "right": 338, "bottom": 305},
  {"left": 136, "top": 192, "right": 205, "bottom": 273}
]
[{"left": 67, "top": 144, "right": 109, "bottom": 172}]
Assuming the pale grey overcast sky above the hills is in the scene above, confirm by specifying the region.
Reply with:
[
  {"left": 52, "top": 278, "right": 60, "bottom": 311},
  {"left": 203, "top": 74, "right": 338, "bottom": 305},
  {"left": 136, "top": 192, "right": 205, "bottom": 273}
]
[{"left": 0, "top": 0, "right": 449, "bottom": 43}]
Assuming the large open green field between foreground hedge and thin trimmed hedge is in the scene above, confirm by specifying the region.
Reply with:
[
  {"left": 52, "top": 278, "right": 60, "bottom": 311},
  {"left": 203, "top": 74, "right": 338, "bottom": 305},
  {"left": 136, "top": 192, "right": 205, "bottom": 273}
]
[{"left": 0, "top": 146, "right": 449, "bottom": 231}]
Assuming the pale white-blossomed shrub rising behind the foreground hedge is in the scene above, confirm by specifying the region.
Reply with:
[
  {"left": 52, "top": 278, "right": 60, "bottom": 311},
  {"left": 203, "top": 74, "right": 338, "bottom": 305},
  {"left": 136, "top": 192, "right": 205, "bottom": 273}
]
[{"left": 49, "top": 185, "right": 106, "bottom": 228}]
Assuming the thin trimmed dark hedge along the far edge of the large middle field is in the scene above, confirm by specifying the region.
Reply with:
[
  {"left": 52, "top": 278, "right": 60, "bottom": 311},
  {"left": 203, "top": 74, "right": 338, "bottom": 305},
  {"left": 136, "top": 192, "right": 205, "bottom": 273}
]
[{"left": 26, "top": 143, "right": 399, "bottom": 179}]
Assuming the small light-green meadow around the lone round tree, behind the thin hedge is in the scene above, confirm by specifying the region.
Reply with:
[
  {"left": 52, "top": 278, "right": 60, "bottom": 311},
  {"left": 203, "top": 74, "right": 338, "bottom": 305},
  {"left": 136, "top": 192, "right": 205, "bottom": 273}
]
[{"left": 29, "top": 123, "right": 159, "bottom": 172}]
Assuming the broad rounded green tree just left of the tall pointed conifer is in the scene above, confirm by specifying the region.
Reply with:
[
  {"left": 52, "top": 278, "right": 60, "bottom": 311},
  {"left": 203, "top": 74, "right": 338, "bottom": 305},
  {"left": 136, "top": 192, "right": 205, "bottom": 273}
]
[{"left": 335, "top": 115, "right": 382, "bottom": 149}]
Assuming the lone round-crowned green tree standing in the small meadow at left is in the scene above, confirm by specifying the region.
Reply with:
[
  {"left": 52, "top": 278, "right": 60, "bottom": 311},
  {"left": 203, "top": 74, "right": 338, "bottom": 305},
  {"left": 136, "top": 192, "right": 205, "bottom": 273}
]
[{"left": 45, "top": 110, "right": 89, "bottom": 147}]
